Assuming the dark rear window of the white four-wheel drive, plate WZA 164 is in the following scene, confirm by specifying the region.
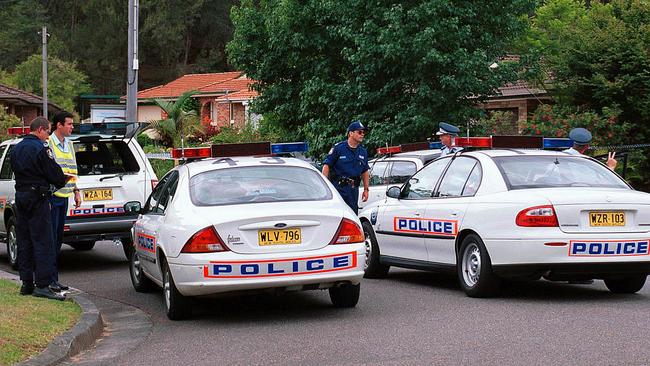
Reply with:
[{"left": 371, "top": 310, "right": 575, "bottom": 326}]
[{"left": 74, "top": 141, "right": 140, "bottom": 175}]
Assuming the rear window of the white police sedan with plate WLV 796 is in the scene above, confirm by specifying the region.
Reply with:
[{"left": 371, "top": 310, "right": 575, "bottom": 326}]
[{"left": 190, "top": 166, "right": 332, "bottom": 206}]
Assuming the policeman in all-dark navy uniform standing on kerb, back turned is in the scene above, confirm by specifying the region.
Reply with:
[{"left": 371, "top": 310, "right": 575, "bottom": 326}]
[{"left": 11, "top": 117, "right": 66, "bottom": 300}]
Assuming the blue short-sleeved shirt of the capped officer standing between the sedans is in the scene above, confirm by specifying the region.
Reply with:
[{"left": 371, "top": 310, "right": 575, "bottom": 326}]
[{"left": 323, "top": 140, "right": 370, "bottom": 179}]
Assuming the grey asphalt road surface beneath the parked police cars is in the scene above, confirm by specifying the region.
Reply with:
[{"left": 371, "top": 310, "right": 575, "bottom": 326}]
[{"left": 0, "top": 242, "right": 650, "bottom": 365}]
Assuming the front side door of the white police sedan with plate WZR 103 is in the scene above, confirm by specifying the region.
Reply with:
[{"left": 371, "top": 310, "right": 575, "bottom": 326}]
[{"left": 375, "top": 158, "right": 450, "bottom": 261}]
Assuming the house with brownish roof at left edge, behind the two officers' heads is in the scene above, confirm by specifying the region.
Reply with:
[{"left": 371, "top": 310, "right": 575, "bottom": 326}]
[{"left": 0, "top": 84, "right": 61, "bottom": 126}]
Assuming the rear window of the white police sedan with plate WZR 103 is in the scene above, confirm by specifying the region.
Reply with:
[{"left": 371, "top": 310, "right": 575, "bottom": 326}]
[{"left": 493, "top": 155, "right": 629, "bottom": 189}]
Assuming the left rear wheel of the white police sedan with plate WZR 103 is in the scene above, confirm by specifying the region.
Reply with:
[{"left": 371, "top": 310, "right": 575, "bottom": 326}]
[{"left": 456, "top": 234, "right": 499, "bottom": 297}]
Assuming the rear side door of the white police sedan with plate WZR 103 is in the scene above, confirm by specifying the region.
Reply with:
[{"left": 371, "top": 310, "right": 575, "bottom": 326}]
[{"left": 424, "top": 156, "right": 482, "bottom": 264}]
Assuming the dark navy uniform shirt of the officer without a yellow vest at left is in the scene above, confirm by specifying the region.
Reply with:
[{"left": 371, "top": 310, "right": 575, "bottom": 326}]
[{"left": 11, "top": 135, "right": 65, "bottom": 190}]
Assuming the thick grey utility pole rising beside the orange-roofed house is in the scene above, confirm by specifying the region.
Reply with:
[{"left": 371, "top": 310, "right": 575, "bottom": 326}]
[{"left": 126, "top": 0, "right": 140, "bottom": 122}]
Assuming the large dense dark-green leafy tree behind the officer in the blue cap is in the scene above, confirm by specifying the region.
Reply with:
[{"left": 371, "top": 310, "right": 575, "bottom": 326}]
[{"left": 227, "top": 0, "right": 534, "bottom": 155}]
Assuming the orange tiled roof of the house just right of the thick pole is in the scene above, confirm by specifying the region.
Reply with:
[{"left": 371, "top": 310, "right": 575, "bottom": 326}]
[{"left": 138, "top": 71, "right": 242, "bottom": 99}]
